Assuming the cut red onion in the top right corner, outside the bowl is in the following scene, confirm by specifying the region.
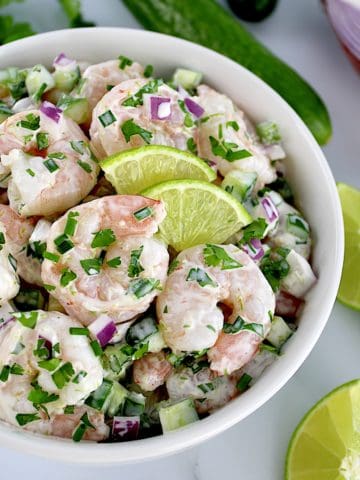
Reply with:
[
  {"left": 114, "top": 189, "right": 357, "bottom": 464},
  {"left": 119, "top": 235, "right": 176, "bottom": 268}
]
[{"left": 325, "top": 0, "right": 360, "bottom": 70}]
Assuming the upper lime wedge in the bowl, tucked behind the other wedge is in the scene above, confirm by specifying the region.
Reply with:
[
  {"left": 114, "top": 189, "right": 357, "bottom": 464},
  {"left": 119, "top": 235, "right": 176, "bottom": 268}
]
[{"left": 101, "top": 145, "right": 216, "bottom": 194}]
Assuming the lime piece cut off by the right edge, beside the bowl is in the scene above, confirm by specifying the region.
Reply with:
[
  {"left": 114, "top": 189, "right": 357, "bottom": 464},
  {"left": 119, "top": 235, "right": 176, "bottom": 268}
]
[{"left": 338, "top": 183, "right": 360, "bottom": 310}]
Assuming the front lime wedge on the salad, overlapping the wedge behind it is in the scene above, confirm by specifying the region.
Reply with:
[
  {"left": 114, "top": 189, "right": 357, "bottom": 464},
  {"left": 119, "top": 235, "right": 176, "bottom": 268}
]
[{"left": 141, "top": 180, "right": 252, "bottom": 252}]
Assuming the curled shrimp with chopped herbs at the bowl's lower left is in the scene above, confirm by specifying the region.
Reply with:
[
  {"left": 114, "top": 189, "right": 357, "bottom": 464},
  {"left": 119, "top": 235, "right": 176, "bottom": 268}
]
[{"left": 0, "top": 310, "right": 103, "bottom": 436}]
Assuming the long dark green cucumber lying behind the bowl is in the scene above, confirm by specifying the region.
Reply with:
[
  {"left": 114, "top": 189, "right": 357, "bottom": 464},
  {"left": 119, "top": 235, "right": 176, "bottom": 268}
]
[{"left": 123, "top": 0, "right": 332, "bottom": 145}]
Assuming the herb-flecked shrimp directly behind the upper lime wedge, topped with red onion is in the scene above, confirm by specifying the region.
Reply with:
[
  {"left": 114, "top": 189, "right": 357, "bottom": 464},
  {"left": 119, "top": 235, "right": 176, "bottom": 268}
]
[{"left": 90, "top": 79, "right": 195, "bottom": 158}]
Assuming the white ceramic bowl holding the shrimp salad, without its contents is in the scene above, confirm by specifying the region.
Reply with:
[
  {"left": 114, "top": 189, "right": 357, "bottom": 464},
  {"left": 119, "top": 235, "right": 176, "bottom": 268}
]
[{"left": 0, "top": 28, "right": 343, "bottom": 464}]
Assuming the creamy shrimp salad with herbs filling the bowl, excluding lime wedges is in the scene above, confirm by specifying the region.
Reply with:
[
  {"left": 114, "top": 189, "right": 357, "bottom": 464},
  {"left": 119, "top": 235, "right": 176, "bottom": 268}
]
[{"left": 0, "top": 53, "right": 316, "bottom": 442}]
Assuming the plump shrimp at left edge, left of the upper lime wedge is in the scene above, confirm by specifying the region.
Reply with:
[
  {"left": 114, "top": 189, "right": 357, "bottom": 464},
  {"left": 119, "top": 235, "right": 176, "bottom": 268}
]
[{"left": 0, "top": 110, "right": 99, "bottom": 216}]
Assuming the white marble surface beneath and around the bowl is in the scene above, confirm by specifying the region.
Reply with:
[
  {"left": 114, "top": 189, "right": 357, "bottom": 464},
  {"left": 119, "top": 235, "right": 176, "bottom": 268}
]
[{"left": 0, "top": 0, "right": 360, "bottom": 480}]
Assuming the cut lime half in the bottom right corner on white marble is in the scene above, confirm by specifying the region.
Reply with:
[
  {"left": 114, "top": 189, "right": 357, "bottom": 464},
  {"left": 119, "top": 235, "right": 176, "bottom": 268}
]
[{"left": 285, "top": 380, "right": 360, "bottom": 480}]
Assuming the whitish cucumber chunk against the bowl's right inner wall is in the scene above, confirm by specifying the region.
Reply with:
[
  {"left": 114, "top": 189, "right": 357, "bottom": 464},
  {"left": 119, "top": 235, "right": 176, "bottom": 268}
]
[{"left": 281, "top": 250, "right": 316, "bottom": 298}]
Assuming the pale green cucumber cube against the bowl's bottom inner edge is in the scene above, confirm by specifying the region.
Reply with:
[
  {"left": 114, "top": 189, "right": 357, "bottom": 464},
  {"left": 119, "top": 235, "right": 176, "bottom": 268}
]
[{"left": 159, "top": 398, "right": 199, "bottom": 433}]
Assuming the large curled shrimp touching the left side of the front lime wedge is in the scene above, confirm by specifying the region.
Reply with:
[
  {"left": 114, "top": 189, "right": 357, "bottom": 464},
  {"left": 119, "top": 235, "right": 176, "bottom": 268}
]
[{"left": 42, "top": 195, "right": 169, "bottom": 325}]
